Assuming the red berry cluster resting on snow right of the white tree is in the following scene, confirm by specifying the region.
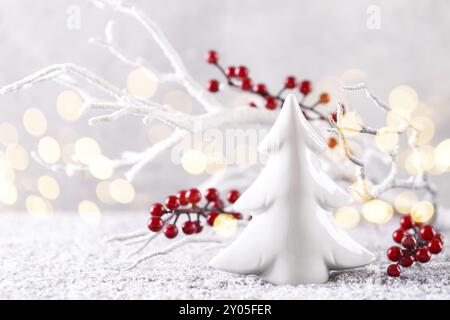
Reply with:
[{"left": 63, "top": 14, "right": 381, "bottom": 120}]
[{"left": 387, "top": 216, "right": 444, "bottom": 277}]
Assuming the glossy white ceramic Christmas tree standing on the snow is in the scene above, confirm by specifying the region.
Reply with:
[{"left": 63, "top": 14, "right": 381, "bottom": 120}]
[{"left": 210, "top": 95, "right": 374, "bottom": 285}]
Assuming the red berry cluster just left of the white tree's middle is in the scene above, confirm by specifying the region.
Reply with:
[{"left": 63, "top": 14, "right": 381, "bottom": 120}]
[{"left": 147, "top": 188, "right": 243, "bottom": 239}]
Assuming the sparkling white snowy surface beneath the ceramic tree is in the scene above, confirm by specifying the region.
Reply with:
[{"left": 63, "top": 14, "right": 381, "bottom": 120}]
[{"left": 0, "top": 213, "right": 450, "bottom": 299}]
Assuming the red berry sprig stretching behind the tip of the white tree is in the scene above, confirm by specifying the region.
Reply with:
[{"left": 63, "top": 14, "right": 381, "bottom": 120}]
[{"left": 206, "top": 50, "right": 336, "bottom": 127}]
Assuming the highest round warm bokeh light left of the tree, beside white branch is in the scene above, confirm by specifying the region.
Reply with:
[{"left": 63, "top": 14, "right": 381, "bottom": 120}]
[{"left": 127, "top": 68, "right": 158, "bottom": 99}]
